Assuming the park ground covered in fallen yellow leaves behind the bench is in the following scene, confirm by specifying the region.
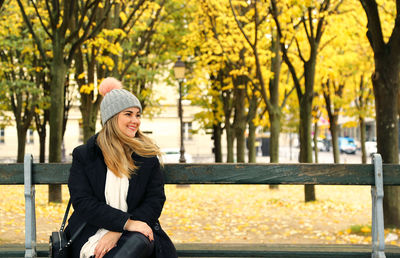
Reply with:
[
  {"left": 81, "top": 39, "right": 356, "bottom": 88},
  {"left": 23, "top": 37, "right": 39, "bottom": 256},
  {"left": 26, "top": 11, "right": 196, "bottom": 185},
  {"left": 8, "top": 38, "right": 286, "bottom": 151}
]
[{"left": 0, "top": 185, "right": 400, "bottom": 246}]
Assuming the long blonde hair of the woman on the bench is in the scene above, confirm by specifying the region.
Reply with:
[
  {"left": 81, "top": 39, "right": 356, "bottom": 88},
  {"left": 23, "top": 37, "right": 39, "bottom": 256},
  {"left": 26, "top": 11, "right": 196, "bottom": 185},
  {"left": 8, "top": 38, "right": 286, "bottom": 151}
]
[{"left": 97, "top": 115, "right": 161, "bottom": 178}]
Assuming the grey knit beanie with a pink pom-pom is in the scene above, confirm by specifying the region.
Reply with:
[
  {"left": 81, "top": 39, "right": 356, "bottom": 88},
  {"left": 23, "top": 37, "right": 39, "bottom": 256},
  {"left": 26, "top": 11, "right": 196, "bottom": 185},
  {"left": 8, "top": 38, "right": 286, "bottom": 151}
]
[{"left": 99, "top": 77, "right": 142, "bottom": 125}]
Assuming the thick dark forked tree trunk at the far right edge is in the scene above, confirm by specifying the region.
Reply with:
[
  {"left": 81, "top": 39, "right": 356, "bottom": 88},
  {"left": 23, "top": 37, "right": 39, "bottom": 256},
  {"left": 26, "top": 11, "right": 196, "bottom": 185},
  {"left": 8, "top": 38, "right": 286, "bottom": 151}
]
[{"left": 360, "top": 0, "right": 400, "bottom": 227}]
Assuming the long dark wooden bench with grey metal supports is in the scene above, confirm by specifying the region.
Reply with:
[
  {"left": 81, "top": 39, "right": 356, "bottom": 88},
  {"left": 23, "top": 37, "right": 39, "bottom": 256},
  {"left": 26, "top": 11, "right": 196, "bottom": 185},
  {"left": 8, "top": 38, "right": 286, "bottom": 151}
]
[{"left": 0, "top": 154, "right": 400, "bottom": 258}]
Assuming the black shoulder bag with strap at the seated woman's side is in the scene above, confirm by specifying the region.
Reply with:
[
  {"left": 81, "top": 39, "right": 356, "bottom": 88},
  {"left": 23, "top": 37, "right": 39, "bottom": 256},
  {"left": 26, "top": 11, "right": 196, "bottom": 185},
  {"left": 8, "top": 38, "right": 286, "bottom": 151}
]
[{"left": 49, "top": 200, "right": 86, "bottom": 258}]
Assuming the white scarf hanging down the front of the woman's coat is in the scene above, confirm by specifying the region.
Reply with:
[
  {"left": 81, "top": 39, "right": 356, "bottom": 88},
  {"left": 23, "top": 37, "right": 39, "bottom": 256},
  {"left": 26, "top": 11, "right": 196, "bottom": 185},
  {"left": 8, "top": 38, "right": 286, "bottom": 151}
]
[{"left": 80, "top": 168, "right": 129, "bottom": 258}]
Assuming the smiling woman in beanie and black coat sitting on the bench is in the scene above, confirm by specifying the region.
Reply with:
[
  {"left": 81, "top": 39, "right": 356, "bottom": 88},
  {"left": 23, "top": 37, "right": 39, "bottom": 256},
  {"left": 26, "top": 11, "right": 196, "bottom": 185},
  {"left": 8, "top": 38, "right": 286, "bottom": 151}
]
[{"left": 65, "top": 78, "right": 177, "bottom": 258}]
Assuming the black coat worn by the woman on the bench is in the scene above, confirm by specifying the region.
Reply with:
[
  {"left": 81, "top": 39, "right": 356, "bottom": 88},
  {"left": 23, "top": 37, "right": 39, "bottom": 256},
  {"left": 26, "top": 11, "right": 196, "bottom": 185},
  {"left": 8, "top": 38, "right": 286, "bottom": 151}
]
[{"left": 66, "top": 135, "right": 177, "bottom": 258}]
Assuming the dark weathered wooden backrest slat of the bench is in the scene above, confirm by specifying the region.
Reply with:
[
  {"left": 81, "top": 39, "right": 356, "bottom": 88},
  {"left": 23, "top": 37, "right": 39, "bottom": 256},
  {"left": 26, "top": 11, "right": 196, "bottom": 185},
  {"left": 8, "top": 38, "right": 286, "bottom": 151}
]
[{"left": 0, "top": 163, "right": 400, "bottom": 185}]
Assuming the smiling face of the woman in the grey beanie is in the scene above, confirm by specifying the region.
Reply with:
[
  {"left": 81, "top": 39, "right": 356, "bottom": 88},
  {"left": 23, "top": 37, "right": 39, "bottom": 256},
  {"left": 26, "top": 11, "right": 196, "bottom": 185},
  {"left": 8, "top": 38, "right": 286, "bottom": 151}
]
[{"left": 118, "top": 107, "right": 141, "bottom": 138}]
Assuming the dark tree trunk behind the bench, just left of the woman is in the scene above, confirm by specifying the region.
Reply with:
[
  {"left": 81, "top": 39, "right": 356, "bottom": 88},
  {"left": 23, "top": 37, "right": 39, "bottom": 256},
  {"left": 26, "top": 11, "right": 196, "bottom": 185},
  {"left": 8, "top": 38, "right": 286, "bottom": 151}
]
[{"left": 49, "top": 34, "right": 67, "bottom": 203}]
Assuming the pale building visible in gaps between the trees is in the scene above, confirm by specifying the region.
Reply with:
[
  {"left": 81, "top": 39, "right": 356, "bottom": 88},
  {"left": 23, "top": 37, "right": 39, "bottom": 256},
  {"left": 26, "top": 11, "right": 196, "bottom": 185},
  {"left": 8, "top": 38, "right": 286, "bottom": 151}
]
[{"left": 0, "top": 81, "right": 378, "bottom": 163}]
